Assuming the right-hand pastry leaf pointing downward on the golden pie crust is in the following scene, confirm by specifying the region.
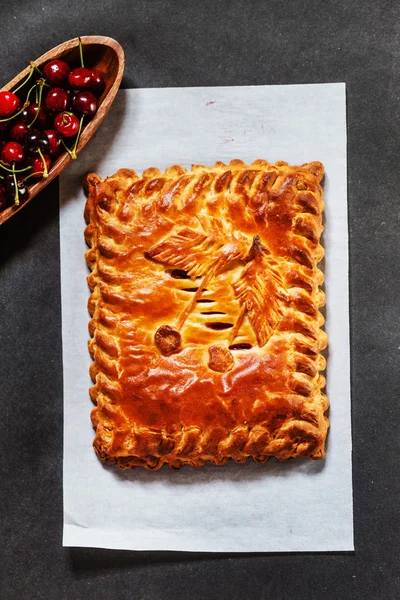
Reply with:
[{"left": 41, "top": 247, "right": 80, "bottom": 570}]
[{"left": 233, "top": 237, "right": 286, "bottom": 347}]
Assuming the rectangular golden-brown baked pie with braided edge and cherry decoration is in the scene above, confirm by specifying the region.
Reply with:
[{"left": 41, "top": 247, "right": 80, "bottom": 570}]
[{"left": 85, "top": 160, "right": 328, "bottom": 469}]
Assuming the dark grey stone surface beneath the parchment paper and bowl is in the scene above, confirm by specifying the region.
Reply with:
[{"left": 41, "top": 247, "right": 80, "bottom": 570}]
[{"left": 0, "top": 0, "right": 400, "bottom": 600}]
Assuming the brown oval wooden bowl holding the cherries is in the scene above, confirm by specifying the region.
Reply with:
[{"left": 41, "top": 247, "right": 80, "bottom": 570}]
[{"left": 0, "top": 35, "right": 125, "bottom": 225}]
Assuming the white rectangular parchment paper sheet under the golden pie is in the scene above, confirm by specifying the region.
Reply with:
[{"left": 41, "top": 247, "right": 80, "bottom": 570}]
[{"left": 60, "top": 83, "right": 353, "bottom": 552}]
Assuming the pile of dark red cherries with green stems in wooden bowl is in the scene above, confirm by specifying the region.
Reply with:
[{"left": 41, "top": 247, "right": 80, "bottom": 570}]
[{"left": 0, "top": 40, "right": 104, "bottom": 211}]
